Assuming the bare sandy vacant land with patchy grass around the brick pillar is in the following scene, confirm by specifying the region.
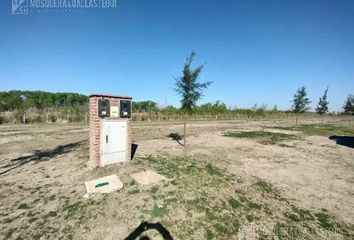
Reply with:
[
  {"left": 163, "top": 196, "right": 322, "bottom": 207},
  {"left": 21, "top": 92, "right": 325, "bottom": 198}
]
[{"left": 0, "top": 120, "right": 354, "bottom": 239}]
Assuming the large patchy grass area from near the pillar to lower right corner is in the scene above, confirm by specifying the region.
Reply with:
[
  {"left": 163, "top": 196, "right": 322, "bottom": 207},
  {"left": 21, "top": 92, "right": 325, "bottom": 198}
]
[{"left": 133, "top": 157, "right": 347, "bottom": 239}]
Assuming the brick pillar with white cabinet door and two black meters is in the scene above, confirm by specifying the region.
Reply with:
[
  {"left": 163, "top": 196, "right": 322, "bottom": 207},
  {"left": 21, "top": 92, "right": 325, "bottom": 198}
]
[{"left": 89, "top": 94, "right": 132, "bottom": 168}]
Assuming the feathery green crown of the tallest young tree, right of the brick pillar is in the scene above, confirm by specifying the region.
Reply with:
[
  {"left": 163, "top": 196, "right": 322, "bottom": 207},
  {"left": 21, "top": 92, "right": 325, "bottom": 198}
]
[{"left": 175, "top": 52, "right": 212, "bottom": 113}]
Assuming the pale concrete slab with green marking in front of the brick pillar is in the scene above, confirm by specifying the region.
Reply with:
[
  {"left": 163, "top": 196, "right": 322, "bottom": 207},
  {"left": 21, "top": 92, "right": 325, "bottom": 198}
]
[{"left": 85, "top": 175, "right": 123, "bottom": 194}]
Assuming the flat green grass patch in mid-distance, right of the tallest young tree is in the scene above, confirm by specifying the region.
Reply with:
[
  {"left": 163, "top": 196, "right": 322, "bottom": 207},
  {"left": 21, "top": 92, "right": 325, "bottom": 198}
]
[{"left": 224, "top": 131, "right": 298, "bottom": 144}]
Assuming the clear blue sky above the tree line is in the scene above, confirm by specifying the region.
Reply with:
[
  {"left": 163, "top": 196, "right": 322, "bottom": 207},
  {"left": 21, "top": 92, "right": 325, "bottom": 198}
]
[{"left": 0, "top": 0, "right": 354, "bottom": 111}]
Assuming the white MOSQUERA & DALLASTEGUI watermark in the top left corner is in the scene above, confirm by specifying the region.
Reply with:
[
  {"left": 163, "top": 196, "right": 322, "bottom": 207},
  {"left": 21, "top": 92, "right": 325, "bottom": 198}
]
[{"left": 12, "top": 0, "right": 117, "bottom": 14}]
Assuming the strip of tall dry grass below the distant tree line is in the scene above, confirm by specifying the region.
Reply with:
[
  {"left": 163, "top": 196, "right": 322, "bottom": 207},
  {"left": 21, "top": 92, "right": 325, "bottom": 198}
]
[{"left": 0, "top": 107, "right": 354, "bottom": 125}]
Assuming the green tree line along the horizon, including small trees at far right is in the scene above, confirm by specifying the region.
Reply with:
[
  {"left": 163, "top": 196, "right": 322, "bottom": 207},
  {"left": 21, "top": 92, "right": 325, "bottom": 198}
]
[{"left": 0, "top": 87, "right": 354, "bottom": 115}]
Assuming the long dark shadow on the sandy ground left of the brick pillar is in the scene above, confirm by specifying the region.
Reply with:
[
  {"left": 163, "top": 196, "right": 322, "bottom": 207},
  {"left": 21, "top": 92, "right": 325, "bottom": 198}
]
[{"left": 0, "top": 140, "right": 87, "bottom": 175}]
